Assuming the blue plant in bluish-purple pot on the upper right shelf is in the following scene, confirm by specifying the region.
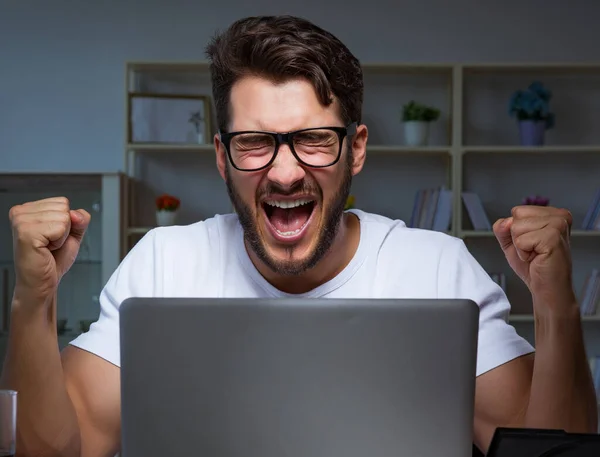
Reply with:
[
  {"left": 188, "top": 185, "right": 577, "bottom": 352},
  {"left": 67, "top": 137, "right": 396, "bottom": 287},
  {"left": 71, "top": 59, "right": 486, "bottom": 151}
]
[{"left": 508, "top": 81, "right": 554, "bottom": 146}]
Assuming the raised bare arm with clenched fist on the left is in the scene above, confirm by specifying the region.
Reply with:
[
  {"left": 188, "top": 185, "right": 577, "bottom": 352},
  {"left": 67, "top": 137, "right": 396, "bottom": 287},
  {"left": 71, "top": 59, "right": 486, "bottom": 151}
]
[{"left": 0, "top": 197, "right": 120, "bottom": 457}]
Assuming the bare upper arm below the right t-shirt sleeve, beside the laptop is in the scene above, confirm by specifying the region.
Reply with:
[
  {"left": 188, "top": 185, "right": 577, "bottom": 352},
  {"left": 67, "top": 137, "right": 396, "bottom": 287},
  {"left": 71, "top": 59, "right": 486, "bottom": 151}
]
[{"left": 474, "top": 353, "right": 534, "bottom": 452}]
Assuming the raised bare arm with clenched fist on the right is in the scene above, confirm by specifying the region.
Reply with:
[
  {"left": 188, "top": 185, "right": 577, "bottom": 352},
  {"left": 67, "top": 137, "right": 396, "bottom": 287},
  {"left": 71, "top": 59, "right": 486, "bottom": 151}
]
[{"left": 475, "top": 206, "right": 598, "bottom": 451}]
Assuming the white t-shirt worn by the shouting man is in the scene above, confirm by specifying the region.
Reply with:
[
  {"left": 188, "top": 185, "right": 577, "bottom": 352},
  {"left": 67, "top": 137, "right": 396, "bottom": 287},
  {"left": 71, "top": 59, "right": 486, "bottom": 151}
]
[{"left": 71, "top": 210, "right": 534, "bottom": 375}]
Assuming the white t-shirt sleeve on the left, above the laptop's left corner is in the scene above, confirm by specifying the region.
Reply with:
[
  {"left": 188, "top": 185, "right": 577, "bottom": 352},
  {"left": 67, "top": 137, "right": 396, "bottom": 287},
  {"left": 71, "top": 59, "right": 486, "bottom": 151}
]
[{"left": 70, "top": 231, "right": 156, "bottom": 367}]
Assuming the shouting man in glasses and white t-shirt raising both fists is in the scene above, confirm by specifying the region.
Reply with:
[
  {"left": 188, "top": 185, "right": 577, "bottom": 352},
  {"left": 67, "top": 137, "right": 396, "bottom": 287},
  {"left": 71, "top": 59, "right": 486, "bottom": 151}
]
[{"left": 2, "top": 13, "right": 597, "bottom": 457}]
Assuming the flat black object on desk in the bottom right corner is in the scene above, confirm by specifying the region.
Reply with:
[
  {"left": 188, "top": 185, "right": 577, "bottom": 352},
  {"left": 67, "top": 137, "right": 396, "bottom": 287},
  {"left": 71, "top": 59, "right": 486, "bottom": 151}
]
[{"left": 486, "top": 428, "right": 600, "bottom": 457}]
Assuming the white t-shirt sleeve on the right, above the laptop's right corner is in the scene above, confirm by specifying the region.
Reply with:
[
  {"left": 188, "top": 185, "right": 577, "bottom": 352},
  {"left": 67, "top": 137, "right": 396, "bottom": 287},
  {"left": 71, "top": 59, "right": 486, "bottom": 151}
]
[{"left": 438, "top": 233, "right": 534, "bottom": 376}]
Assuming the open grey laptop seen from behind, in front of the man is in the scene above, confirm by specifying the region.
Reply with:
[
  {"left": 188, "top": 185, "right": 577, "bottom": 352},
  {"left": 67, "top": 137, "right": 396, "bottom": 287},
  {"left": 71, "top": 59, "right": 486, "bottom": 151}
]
[{"left": 120, "top": 298, "right": 479, "bottom": 457}]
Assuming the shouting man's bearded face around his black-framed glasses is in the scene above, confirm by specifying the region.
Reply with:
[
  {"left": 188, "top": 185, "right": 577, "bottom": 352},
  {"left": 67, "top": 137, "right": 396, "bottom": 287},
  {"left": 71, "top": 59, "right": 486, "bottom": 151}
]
[{"left": 217, "top": 77, "right": 353, "bottom": 275}]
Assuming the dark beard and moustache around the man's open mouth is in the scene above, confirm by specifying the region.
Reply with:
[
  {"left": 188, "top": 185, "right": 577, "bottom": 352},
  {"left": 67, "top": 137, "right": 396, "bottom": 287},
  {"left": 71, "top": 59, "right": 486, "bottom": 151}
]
[{"left": 225, "top": 154, "right": 352, "bottom": 276}]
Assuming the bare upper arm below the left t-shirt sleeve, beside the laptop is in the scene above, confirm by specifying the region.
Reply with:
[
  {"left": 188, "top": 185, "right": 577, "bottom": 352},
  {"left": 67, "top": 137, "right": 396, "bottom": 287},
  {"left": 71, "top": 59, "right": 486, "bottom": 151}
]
[{"left": 62, "top": 345, "right": 121, "bottom": 457}]
